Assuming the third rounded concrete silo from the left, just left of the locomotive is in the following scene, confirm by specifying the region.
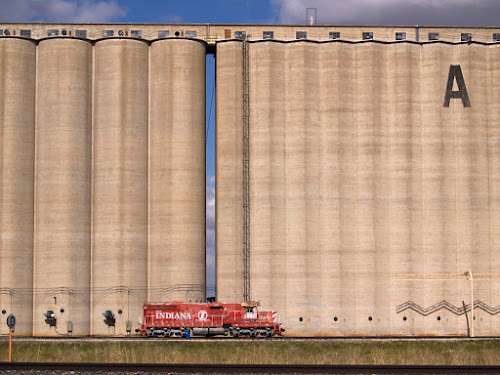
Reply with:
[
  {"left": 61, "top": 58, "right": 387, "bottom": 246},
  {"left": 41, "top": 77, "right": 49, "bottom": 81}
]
[{"left": 92, "top": 39, "right": 148, "bottom": 335}]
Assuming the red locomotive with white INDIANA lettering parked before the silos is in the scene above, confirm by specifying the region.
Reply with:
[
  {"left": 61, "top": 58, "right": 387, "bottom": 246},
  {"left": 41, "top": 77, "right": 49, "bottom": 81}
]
[{"left": 141, "top": 302, "right": 285, "bottom": 337}]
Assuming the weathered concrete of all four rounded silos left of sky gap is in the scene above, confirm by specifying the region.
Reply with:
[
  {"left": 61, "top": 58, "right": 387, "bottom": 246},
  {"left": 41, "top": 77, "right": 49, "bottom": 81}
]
[{"left": 0, "top": 37, "right": 206, "bottom": 336}]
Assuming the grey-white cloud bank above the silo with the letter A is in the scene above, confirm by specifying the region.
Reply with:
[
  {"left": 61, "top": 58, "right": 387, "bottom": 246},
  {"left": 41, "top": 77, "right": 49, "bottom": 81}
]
[{"left": 271, "top": 0, "right": 500, "bottom": 26}]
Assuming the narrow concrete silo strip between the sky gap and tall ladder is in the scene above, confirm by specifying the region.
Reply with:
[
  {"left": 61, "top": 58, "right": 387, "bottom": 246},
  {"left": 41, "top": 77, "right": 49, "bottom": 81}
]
[{"left": 215, "top": 42, "right": 243, "bottom": 302}]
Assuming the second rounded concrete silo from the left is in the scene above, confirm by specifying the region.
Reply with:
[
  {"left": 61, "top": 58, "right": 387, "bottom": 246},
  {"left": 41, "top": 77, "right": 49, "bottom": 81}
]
[{"left": 33, "top": 38, "right": 92, "bottom": 335}]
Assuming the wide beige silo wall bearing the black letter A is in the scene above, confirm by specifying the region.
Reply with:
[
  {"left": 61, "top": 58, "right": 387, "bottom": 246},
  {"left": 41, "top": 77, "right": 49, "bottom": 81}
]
[{"left": 216, "top": 41, "right": 500, "bottom": 336}]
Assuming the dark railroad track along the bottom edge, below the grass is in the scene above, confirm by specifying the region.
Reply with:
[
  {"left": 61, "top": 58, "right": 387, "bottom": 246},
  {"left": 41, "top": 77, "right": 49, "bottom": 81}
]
[{"left": 0, "top": 362, "right": 500, "bottom": 375}]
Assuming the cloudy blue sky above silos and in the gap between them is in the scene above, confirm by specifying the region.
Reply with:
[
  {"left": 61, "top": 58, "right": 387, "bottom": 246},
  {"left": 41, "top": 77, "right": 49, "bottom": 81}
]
[{"left": 0, "top": 0, "right": 500, "bottom": 300}]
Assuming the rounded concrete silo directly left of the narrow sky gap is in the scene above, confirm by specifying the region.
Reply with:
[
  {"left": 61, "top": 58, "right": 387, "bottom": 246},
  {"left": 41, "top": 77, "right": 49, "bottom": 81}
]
[{"left": 149, "top": 39, "right": 205, "bottom": 302}]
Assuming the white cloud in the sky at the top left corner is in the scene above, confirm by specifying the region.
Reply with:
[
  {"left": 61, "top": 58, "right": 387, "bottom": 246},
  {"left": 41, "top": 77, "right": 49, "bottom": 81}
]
[{"left": 0, "top": 0, "right": 127, "bottom": 22}]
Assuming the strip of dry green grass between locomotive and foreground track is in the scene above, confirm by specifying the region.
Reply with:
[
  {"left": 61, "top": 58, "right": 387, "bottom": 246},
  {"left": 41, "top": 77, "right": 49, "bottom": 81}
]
[{"left": 0, "top": 340, "right": 500, "bottom": 365}]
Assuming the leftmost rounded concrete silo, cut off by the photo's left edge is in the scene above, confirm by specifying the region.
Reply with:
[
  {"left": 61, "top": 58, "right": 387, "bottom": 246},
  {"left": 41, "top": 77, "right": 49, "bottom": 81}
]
[{"left": 0, "top": 39, "right": 36, "bottom": 335}]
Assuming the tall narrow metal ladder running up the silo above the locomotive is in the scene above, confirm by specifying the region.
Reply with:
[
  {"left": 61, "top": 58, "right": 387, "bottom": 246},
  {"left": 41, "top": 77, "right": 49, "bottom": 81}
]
[{"left": 242, "top": 39, "right": 250, "bottom": 302}]
